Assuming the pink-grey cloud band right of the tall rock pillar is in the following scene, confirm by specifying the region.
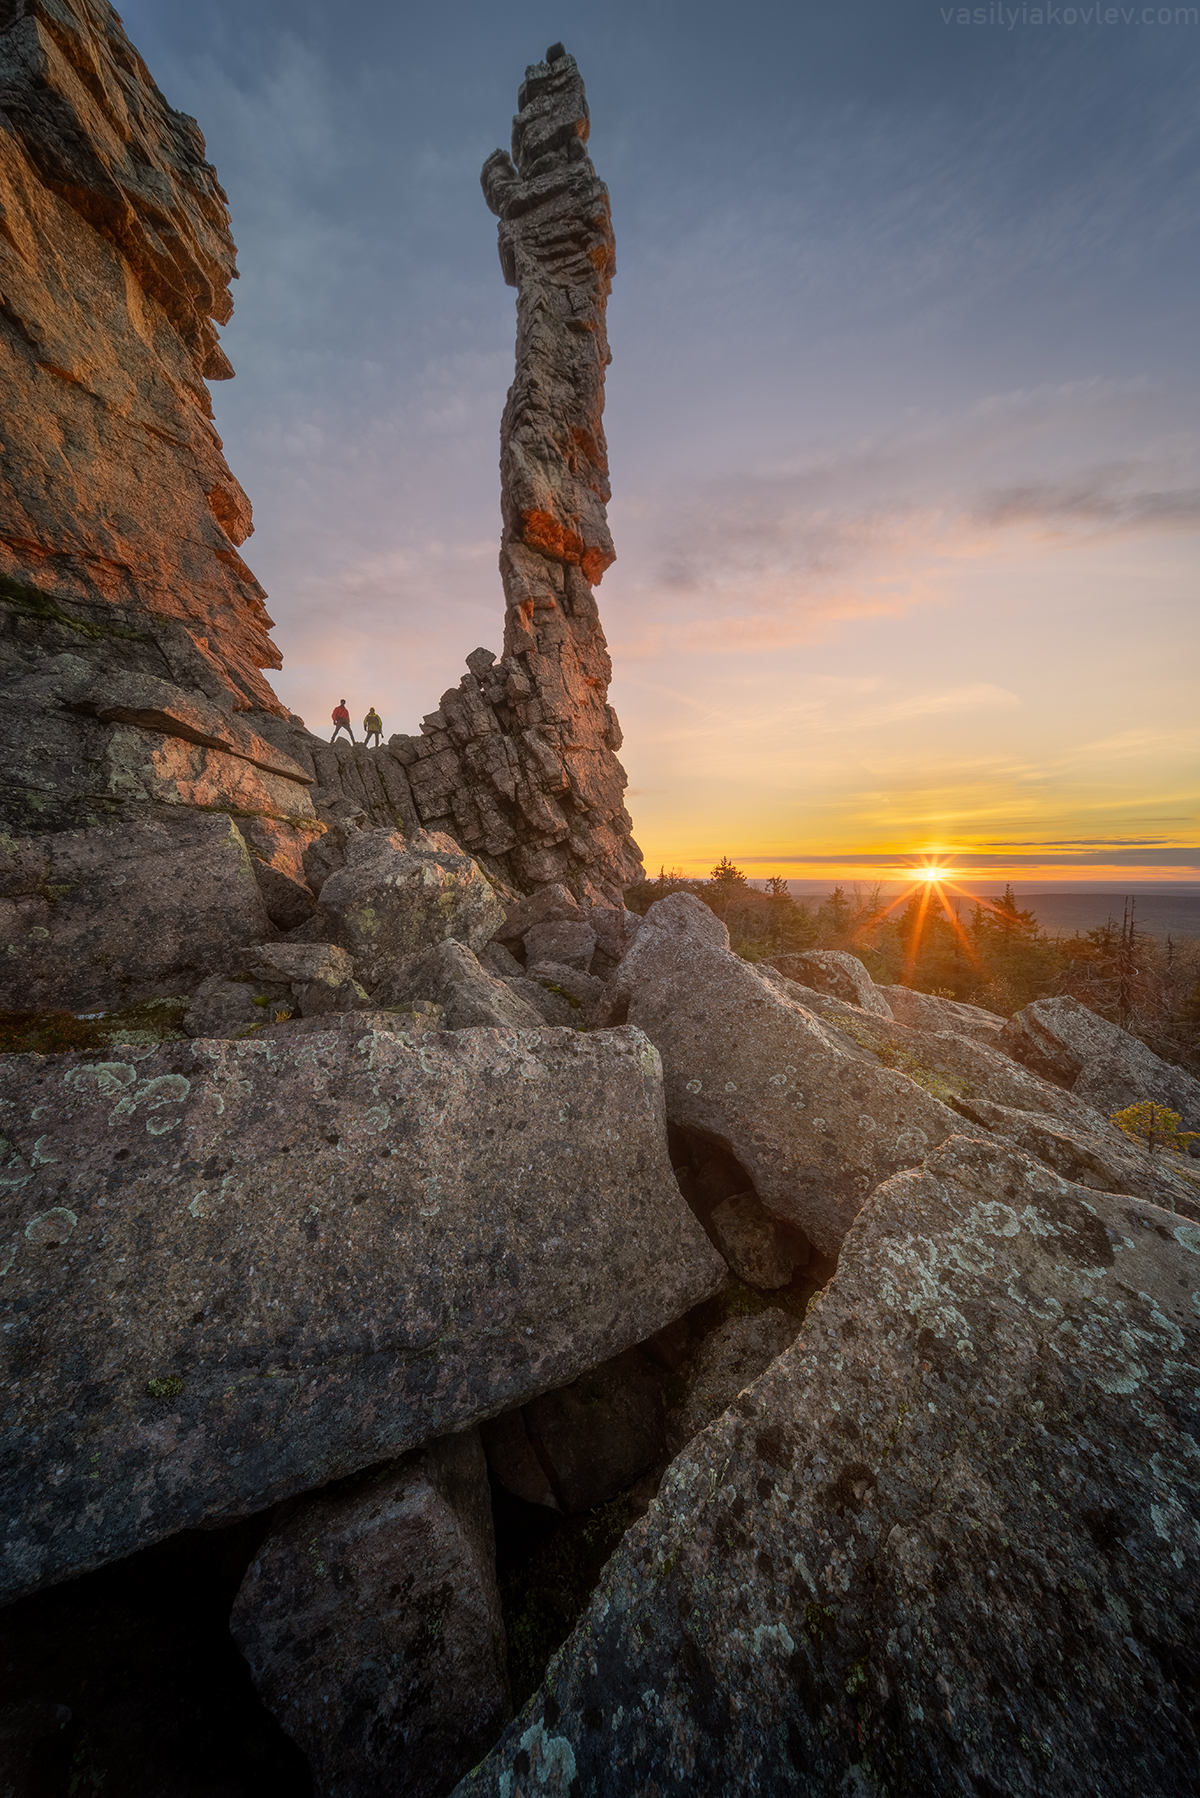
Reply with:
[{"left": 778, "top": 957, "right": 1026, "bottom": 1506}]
[{"left": 604, "top": 379, "right": 1200, "bottom": 660}]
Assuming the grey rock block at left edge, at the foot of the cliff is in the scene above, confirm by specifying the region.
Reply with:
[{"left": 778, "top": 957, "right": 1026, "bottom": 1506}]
[{"left": 0, "top": 812, "right": 272, "bottom": 1010}]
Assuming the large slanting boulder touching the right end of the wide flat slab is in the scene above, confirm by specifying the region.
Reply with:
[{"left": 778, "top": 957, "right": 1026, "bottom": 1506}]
[{"left": 604, "top": 894, "right": 957, "bottom": 1255}]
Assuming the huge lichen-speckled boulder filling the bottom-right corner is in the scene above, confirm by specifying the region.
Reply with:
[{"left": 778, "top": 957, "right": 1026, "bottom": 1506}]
[{"left": 457, "top": 1138, "right": 1200, "bottom": 1798}]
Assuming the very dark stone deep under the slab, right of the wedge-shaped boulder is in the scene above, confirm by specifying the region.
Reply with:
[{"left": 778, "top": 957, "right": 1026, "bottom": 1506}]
[{"left": 522, "top": 1349, "right": 666, "bottom": 1516}]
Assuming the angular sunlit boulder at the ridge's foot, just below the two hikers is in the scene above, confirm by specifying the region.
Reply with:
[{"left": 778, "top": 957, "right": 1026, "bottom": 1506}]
[{"left": 320, "top": 831, "right": 504, "bottom": 991}]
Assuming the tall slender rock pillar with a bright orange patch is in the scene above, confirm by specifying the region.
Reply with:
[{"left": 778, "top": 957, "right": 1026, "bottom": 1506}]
[{"left": 467, "top": 45, "right": 640, "bottom": 895}]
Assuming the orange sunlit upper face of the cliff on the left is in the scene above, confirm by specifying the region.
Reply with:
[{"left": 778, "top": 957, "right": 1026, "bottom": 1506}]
[{"left": 0, "top": 0, "right": 286, "bottom": 716}]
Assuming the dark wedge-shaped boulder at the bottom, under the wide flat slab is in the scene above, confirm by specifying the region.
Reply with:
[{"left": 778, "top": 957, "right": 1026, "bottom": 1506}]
[{"left": 230, "top": 1431, "right": 513, "bottom": 1798}]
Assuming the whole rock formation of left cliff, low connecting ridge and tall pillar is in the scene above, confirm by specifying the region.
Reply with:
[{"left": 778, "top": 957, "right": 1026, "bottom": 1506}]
[{"left": 0, "top": 21, "right": 640, "bottom": 1010}]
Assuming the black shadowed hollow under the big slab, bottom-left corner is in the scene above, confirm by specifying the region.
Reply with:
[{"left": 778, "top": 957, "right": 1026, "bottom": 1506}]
[{"left": 0, "top": 1510, "right": 313, "bottom": 1798}]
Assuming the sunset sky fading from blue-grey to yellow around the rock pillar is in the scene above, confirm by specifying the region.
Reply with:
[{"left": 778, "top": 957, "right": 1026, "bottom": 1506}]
[{"left": 121, "top": 0, "right": 1200, "bottom": 890}]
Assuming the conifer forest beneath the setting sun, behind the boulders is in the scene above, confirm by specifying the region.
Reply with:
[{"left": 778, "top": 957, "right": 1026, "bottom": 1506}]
[{"left": 624, "top": 858, "right": 1200, "bottom": 1070}]
